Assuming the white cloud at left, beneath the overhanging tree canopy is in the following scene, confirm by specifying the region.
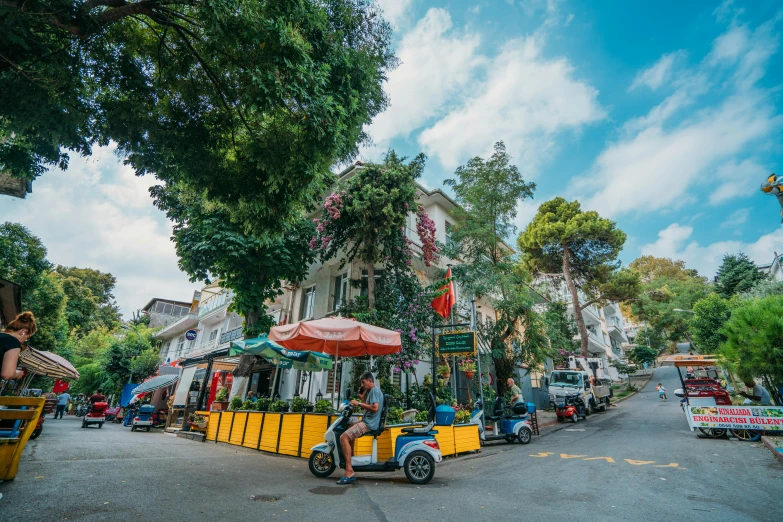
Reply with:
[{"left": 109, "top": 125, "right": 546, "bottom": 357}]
[{"left": 0, "top": 147, "right": 198, "bottom": 317}]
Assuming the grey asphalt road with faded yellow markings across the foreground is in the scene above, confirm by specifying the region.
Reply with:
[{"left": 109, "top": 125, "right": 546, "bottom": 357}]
[{"left": 0, "top": 367, "right": 783, "bottom": 522}]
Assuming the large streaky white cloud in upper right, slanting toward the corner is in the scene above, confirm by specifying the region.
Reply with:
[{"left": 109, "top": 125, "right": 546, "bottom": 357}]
[{"left": 573, "top": 14, "right": 783, "bottom": 216}]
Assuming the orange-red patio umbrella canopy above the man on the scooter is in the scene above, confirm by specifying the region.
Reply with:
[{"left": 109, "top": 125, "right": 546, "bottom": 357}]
[{"left": 269, "top": 317, "right": 402, "bottom": 357}]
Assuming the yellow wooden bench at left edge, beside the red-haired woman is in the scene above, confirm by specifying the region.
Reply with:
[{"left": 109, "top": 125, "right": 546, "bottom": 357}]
[{"left": 0, "top": 397, "right": 45, "bottom": 480}]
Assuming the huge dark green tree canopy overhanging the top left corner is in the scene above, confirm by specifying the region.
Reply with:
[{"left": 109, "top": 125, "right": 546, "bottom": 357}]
[{"left": 0, "top": 0, "right": 396, "bottom": 230}]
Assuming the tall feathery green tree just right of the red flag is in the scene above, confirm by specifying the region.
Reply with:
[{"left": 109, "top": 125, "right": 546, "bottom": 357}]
[{"left": 443, "top": 142, "right": 553, "bottom": 392}]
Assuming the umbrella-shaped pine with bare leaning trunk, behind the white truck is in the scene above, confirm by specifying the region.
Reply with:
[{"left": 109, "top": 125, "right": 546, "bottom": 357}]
[{"left": 518, "top": 198, "right": 639, "bottom": 357}]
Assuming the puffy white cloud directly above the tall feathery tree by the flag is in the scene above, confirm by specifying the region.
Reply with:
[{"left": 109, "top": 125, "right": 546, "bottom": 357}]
[{"left": 419, "top": 37, "right": 605, "bottom": 173}]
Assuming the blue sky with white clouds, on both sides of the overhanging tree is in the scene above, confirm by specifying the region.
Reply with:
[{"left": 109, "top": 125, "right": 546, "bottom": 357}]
[{"left": 0, "top": 0, "right": 783, "bottom": 314}]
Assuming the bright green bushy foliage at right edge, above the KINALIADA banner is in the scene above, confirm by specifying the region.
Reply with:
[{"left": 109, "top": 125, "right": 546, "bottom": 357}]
[{"left": 720, "top": 295, "right": 783, "bottom": 382}]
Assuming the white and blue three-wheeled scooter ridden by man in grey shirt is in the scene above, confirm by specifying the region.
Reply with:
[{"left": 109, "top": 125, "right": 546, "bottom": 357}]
[{"left": 309, "top": 395, "right": 444, "bottom": 484}]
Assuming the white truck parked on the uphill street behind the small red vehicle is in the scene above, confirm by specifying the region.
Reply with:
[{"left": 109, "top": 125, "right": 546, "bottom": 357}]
[{"left": 549, "top": 356, "right": 612, "bottom": 414}]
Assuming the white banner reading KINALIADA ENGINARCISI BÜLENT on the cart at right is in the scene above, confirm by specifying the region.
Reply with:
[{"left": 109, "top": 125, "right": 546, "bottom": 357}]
[{"left": 685, "top": 405, "right": 783, "bottom": 431}]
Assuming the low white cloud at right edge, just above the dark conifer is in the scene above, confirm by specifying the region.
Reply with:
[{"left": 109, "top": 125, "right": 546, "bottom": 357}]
[{"left": 641, "top": 223, "right": 783, "bottom": 278}]
